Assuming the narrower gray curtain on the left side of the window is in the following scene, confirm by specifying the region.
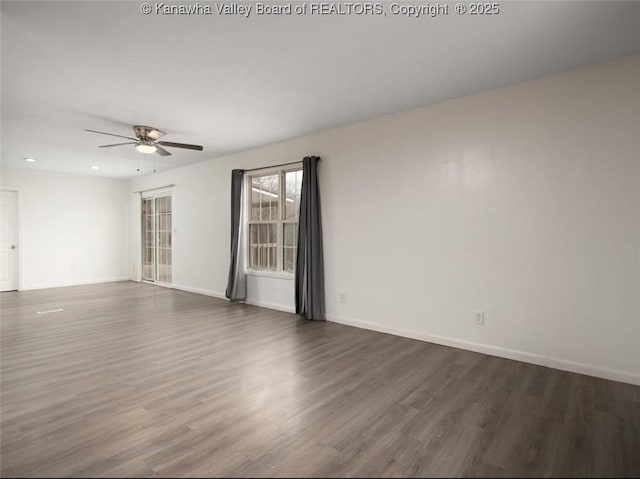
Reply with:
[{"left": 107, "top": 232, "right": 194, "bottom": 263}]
[{"left": 224, "top": 170, "right": 247, "bottom": 301}]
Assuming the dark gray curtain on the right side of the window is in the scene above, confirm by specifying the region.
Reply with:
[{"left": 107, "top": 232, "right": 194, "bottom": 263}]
[{"left": 295, "top": 156, "right": 325, "bottom": 320}]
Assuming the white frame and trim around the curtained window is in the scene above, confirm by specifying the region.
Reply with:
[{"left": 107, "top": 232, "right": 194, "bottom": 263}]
[{"left": 244, "top": 162, "right": 302, "bottom": 280}]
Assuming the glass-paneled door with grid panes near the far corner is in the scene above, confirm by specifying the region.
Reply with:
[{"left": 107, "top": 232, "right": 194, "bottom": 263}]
[{"left": 142, "top": 195, "right": 172, "bottom": 283}]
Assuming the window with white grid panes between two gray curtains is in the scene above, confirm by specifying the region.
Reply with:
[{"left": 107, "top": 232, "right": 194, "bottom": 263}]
[{"left": 247, "top": 167, "right": 302, "bottom": 273}]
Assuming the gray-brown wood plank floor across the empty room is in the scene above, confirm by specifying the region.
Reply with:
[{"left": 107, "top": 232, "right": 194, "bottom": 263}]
[{"left": 0, "top": 282, "right": 640, "bottom": 477}]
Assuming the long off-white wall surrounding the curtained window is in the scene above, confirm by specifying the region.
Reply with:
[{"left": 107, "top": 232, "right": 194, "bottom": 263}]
[{"left": 133, "top": 55, "right": 640, "bottom": 384}]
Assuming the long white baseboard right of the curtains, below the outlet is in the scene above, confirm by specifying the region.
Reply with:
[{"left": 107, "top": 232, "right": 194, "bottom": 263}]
[{"left": 327, "top": 315, "right": 640, "bottom": 386}]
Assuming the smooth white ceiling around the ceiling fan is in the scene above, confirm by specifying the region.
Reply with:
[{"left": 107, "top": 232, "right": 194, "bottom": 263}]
[{"left": 1, "top": 0, "right": 640, "bottom": 178}]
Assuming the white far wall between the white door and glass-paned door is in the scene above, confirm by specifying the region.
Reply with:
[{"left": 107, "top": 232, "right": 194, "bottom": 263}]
[{"left": 2, "top": 168, "right": 131, "bottom": 289}]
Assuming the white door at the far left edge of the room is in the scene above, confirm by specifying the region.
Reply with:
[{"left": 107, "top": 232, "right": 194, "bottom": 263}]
[{"left": 0, "top": 190, "right": 18, "bottom": 291}]
